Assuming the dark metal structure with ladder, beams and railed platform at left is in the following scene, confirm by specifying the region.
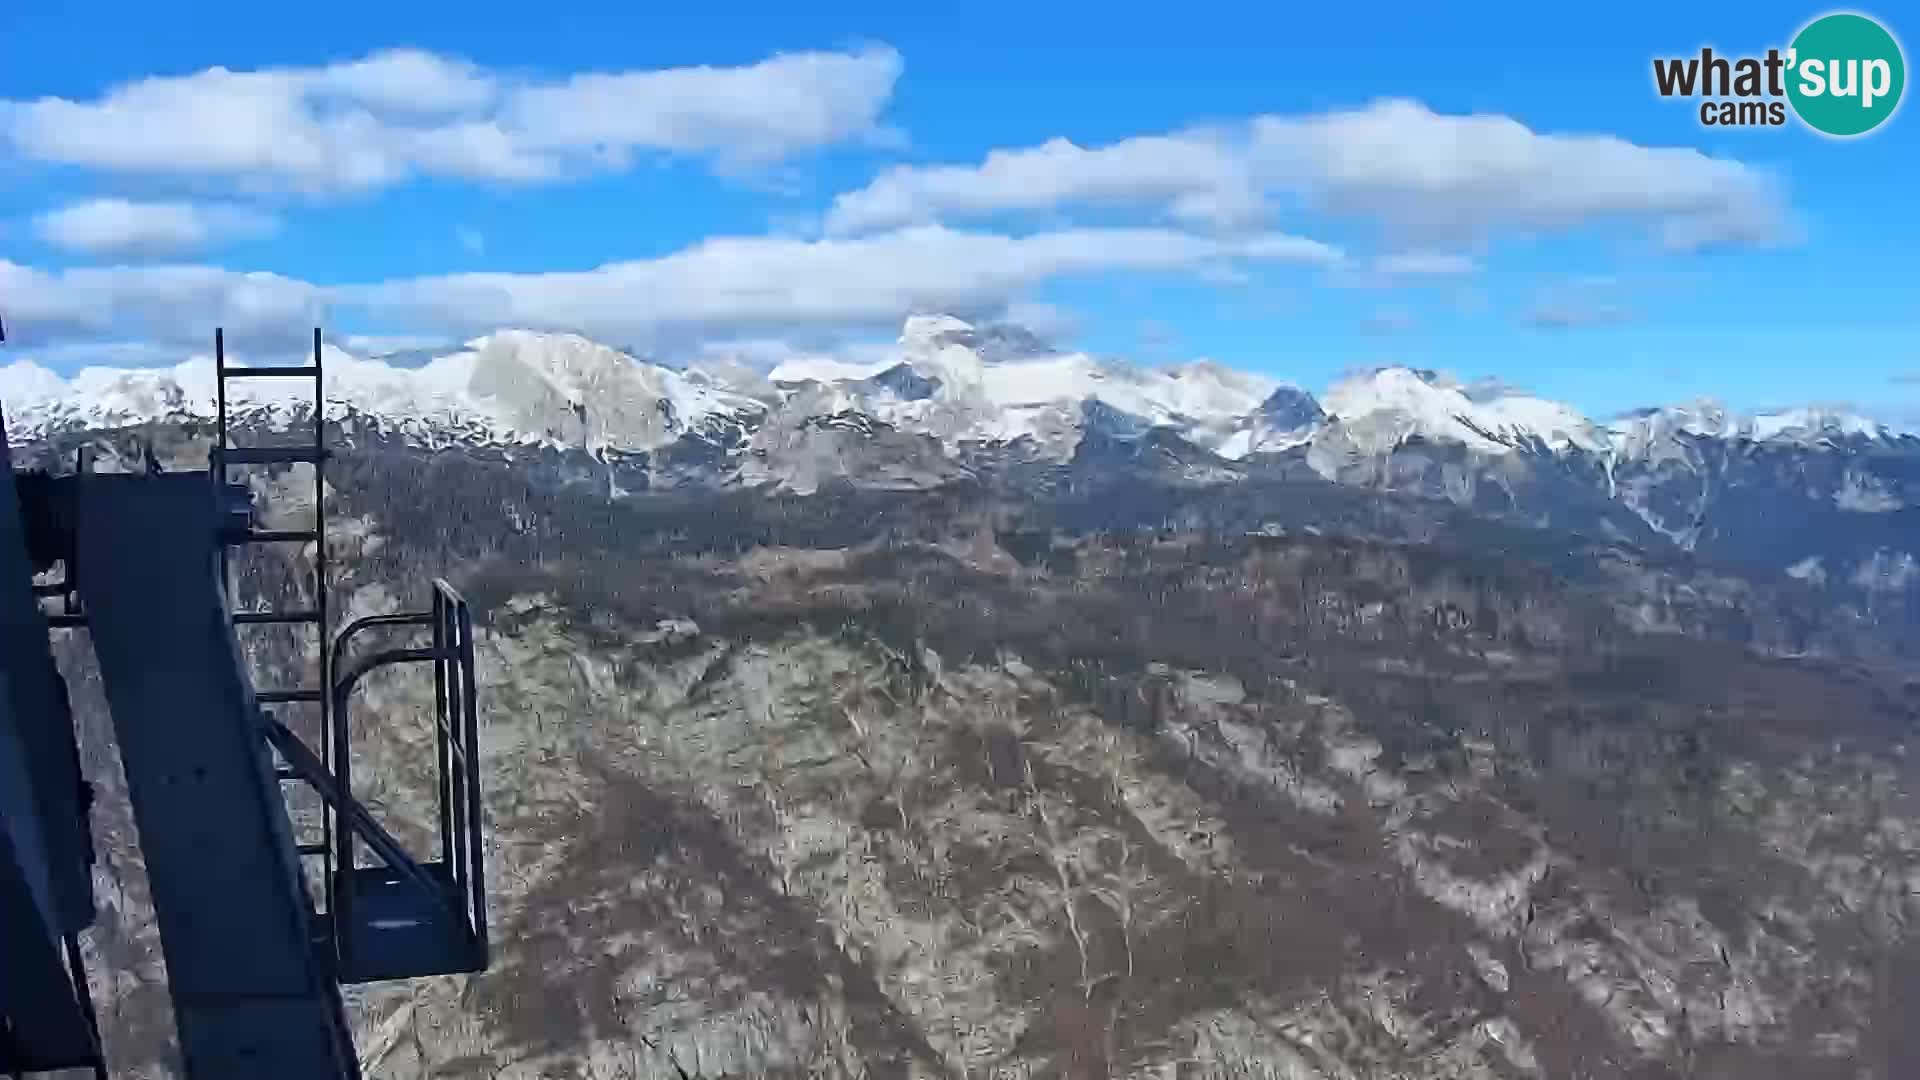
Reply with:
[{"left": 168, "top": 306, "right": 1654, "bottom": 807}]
[{"left": 0, "top": 322, "right": 488, "bottom": 1080}]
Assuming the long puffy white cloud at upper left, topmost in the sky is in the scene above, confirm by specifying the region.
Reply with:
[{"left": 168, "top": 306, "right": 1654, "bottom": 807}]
[{"left": 0, "top": 46, "right": 900, "bottom": 192}]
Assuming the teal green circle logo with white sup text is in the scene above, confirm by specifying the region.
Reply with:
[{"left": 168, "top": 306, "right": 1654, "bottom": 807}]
[{"left": 1788, "top": 13, "right": 1907, "bottom": 138}]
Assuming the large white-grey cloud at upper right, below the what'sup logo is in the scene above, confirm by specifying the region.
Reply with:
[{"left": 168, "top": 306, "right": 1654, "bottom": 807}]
[{"left": 826, "top": 100, "right": 1788, "bottom": 250}]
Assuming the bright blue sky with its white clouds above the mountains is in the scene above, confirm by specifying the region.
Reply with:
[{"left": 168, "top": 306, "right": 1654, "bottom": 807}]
[{"left": 0, "top": 0, "right": 1920, "bottom": 419}]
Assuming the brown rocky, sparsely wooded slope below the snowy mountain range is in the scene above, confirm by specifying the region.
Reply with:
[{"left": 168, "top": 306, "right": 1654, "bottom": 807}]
[{"left": 37, "top": 432, "right": 1920, "bottom": 1080}]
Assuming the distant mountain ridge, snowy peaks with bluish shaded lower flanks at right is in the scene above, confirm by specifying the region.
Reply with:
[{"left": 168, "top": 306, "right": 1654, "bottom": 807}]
[{"left": 0, "top": 315, "right": 1920, "bottom": 615}]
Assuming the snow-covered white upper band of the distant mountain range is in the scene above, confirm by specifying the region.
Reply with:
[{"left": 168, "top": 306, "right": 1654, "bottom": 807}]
[{"left": 0, "top": 307, "right": 1897, "bottom": 461}]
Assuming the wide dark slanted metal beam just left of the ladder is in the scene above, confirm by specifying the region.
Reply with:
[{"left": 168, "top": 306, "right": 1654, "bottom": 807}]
[{"left": 79, "top": 473, "right": 359, "bottom": 1080}]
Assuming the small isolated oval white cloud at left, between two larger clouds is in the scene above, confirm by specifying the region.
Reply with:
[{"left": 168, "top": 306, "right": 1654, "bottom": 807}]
[{"left": 33, "top": 198, "right": 278, "bottom": 258}]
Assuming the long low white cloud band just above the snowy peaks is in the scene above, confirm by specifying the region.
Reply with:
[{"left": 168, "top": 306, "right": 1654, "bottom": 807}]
[{"left": 0, "top": 225, "right": 1340, "bottom": 348}]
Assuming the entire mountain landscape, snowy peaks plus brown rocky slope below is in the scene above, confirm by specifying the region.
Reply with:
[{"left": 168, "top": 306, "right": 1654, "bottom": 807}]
[{"left": 11, "top": 321, "right": 1920, "bottom": 1080}]
